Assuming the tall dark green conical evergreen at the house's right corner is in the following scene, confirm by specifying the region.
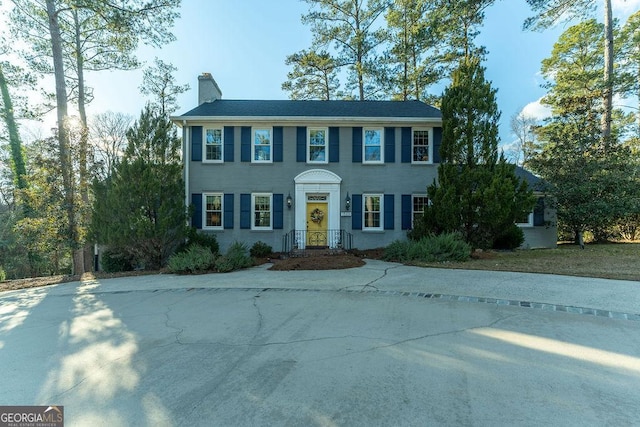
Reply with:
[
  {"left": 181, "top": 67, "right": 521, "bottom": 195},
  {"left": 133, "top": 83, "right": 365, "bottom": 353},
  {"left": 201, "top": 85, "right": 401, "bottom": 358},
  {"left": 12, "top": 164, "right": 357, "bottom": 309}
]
[{"left": 424, "top": 57, "right": 535, "bottom": 248}]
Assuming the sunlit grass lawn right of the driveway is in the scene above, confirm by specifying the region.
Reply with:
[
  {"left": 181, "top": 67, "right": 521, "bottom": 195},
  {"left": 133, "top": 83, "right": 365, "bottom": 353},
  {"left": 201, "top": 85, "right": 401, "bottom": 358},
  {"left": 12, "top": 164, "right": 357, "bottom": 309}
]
[{"left": 419, "top": 243, "right": 640, "bottom": 281}]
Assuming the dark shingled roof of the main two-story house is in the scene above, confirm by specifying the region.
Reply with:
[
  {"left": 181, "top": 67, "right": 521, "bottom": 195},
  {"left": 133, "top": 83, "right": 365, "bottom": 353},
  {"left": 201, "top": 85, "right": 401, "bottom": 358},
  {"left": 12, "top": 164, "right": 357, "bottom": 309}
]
[{"left": 176, "top": 99, "right": 442, "bottom": 119}]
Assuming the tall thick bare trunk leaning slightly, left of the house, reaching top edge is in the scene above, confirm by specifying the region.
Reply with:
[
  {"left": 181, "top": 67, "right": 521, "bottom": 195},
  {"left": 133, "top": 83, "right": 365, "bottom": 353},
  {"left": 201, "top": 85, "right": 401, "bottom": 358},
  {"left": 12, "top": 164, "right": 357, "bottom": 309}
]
[{"left": 46, "top": 0, "right": 84, "bottom": 274}]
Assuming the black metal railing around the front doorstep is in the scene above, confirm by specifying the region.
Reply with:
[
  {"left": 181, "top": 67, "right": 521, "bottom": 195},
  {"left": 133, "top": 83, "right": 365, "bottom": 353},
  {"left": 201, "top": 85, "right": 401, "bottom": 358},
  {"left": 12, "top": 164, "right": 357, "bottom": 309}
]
[{"left": 282, "top": 230, "right": 353, "bottom": 254}]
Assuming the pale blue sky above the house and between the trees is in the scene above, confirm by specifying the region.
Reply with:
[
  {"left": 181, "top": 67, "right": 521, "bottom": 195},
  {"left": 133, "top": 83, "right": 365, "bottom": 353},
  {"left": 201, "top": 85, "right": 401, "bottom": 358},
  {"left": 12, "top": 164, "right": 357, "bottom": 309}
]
[{"left": 46, "top": 0, "right": 640, "bottom": 144}]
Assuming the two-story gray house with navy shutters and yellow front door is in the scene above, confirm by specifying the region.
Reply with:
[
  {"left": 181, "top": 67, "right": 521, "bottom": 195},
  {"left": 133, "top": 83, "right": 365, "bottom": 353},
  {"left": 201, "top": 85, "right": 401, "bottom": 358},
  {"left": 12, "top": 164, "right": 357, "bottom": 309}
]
[{"left": 172, "top": 73, "right": 555, "bottom": 254}]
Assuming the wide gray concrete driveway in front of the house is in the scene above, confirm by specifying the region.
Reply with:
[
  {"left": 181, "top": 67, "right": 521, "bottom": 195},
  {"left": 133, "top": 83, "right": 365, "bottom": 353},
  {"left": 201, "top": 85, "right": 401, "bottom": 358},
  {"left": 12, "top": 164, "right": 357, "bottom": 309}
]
[{"left": 0, "top": 261, "right": 640, "bottom": 426}]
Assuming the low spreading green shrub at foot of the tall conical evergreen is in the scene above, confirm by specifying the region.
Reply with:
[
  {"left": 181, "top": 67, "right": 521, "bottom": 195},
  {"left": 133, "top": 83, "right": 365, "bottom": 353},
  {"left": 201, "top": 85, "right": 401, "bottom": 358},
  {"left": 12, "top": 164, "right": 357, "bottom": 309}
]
[{"left": 383, "top": 233, "right": 471, "bottom": 262}]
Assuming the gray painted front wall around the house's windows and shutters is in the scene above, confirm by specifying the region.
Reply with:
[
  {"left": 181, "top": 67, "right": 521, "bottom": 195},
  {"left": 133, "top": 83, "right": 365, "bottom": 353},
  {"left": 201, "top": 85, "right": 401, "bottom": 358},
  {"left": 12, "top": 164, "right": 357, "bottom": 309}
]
[{"left": 189, "top": 125, "right": 437, "bottom": 251}]
